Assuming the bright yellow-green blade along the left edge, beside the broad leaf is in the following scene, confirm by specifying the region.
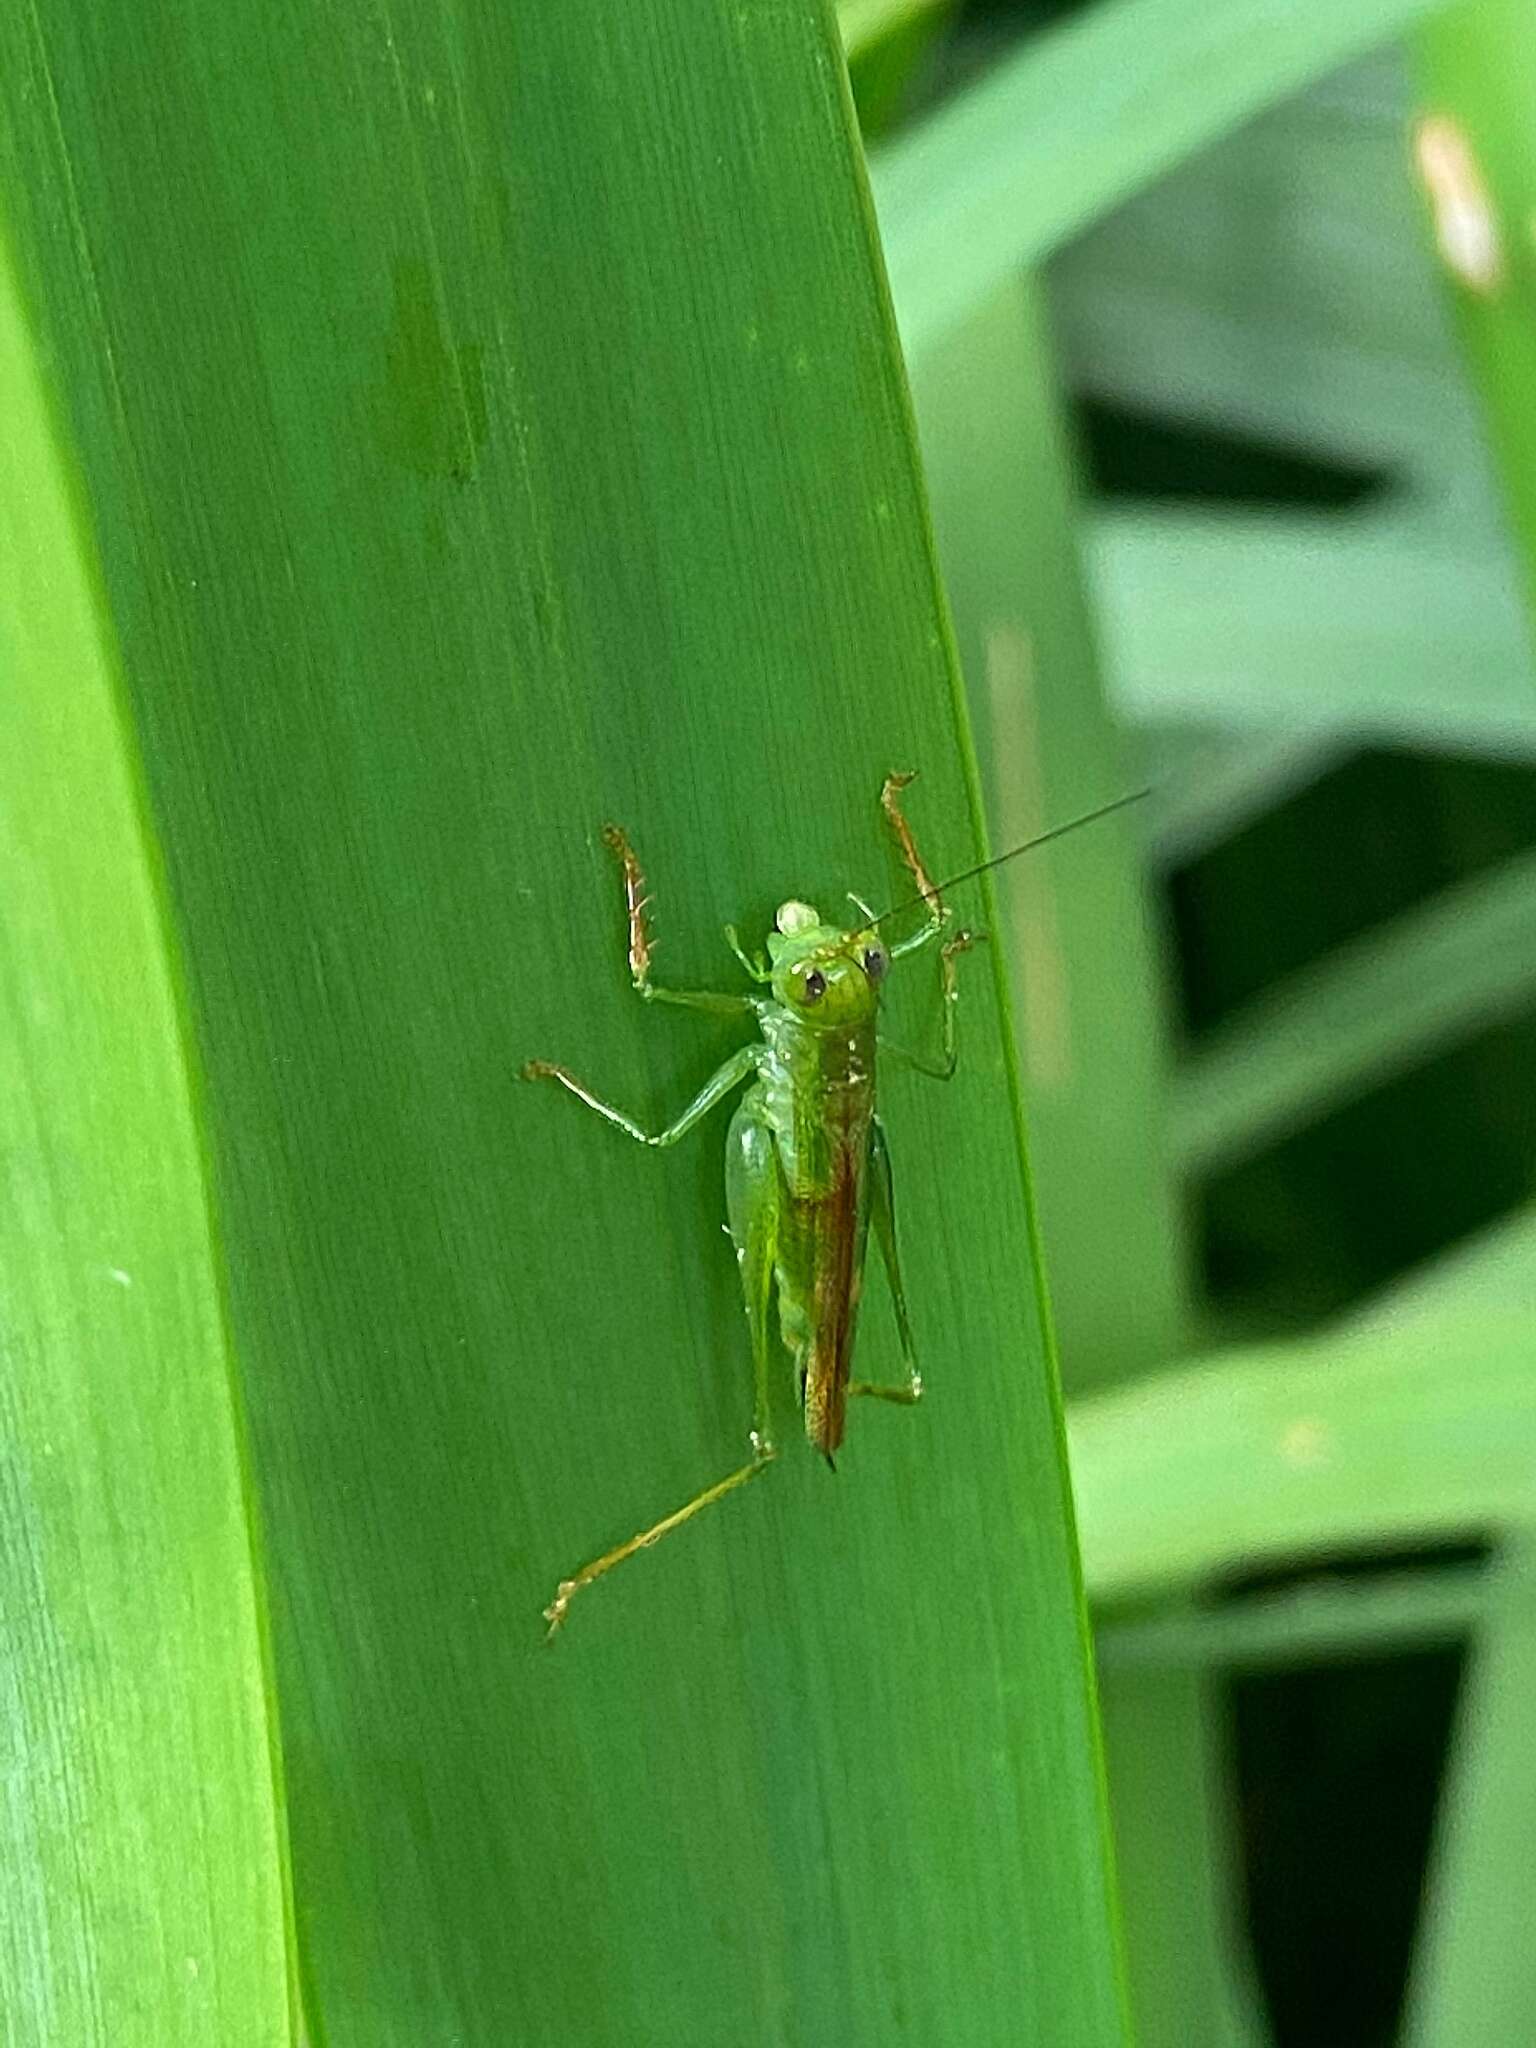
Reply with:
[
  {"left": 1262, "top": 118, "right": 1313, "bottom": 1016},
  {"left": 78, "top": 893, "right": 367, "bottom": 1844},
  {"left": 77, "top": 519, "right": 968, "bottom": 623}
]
[{"left": 0, "top": 220, "right": 289, "bottom": 2048}]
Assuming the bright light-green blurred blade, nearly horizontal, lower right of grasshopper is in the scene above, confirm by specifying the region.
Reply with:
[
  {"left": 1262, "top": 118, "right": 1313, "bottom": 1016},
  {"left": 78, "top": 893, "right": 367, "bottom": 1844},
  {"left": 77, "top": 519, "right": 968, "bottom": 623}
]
[{"left": 1071, "top": 1307, "right": 1536, "bottom": 1602}]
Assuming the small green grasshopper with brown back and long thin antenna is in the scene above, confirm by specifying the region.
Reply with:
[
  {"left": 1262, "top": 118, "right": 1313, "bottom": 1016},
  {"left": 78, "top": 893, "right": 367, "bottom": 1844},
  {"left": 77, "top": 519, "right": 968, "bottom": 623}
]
[{"left": 522, "top": 774, "right": 1133, "bottom": 1636}]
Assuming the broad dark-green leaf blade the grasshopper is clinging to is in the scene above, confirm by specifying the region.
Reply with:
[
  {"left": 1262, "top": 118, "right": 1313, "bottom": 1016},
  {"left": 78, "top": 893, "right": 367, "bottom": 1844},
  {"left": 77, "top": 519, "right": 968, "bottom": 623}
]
[{"left": 0, "top": 0, "right": 1122, "bottom": 2048}]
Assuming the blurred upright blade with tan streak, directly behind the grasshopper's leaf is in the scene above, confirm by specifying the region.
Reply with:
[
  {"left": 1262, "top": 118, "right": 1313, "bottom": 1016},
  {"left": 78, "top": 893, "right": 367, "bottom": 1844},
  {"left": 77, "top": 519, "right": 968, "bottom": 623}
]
[{"left": 915, "top": 281, "right": 1257, "bottom": 2048}]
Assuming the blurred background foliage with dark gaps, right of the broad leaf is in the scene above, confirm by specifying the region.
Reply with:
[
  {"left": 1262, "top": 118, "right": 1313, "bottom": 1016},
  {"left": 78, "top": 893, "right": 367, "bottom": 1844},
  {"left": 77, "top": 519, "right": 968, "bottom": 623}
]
[{"left": 848, "top": 0, "right": 1536, "bottom": 2048}]
